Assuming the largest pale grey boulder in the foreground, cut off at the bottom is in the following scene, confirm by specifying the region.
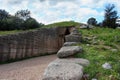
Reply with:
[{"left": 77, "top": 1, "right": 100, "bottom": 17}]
[{"left": 42, "top": 63, "right": 83, "bottom": 80}]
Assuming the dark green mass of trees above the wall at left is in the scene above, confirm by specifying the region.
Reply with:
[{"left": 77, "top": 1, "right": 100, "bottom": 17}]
[{"left": 0, "top": 10, "right": 43, "bottom": 31}]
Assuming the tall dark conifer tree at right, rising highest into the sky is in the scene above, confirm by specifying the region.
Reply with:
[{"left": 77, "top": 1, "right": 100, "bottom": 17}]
[{"left": 103, "top": 4, "right": 118, "bottom": 28}]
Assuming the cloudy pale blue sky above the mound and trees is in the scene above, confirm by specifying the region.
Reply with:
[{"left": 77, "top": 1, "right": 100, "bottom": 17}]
[{"left": 0, "top": 0, "right": 120, "bottom": 24}]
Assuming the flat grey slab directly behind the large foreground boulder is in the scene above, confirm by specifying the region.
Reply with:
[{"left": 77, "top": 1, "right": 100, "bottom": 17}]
[{"left": 53, "top": 58, "right": 90, "bottom": 66}]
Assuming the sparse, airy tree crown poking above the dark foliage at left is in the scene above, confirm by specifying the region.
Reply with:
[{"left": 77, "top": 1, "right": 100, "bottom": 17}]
[{"left": 15, "top": 10, "right": 30, "bottom": 21}]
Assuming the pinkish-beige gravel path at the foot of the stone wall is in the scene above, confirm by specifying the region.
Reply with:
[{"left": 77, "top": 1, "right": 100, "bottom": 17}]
[{"left": 0, "top": 55, "right": 56, "bottom": 80}]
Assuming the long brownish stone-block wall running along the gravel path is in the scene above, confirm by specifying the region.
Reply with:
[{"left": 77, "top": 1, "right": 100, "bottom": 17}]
[{"left": 0, "top": 27, "right": 72, "bottom": 62}]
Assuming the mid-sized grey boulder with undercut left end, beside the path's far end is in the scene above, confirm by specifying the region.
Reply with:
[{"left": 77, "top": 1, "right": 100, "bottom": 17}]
[{"left": 57, "top": 46, "right": 82, "bottom": 58}]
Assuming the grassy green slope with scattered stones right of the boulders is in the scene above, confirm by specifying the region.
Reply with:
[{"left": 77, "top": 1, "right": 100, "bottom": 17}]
[{"left": 76, "top": 28, "right": 120, "bottom": 80}]
